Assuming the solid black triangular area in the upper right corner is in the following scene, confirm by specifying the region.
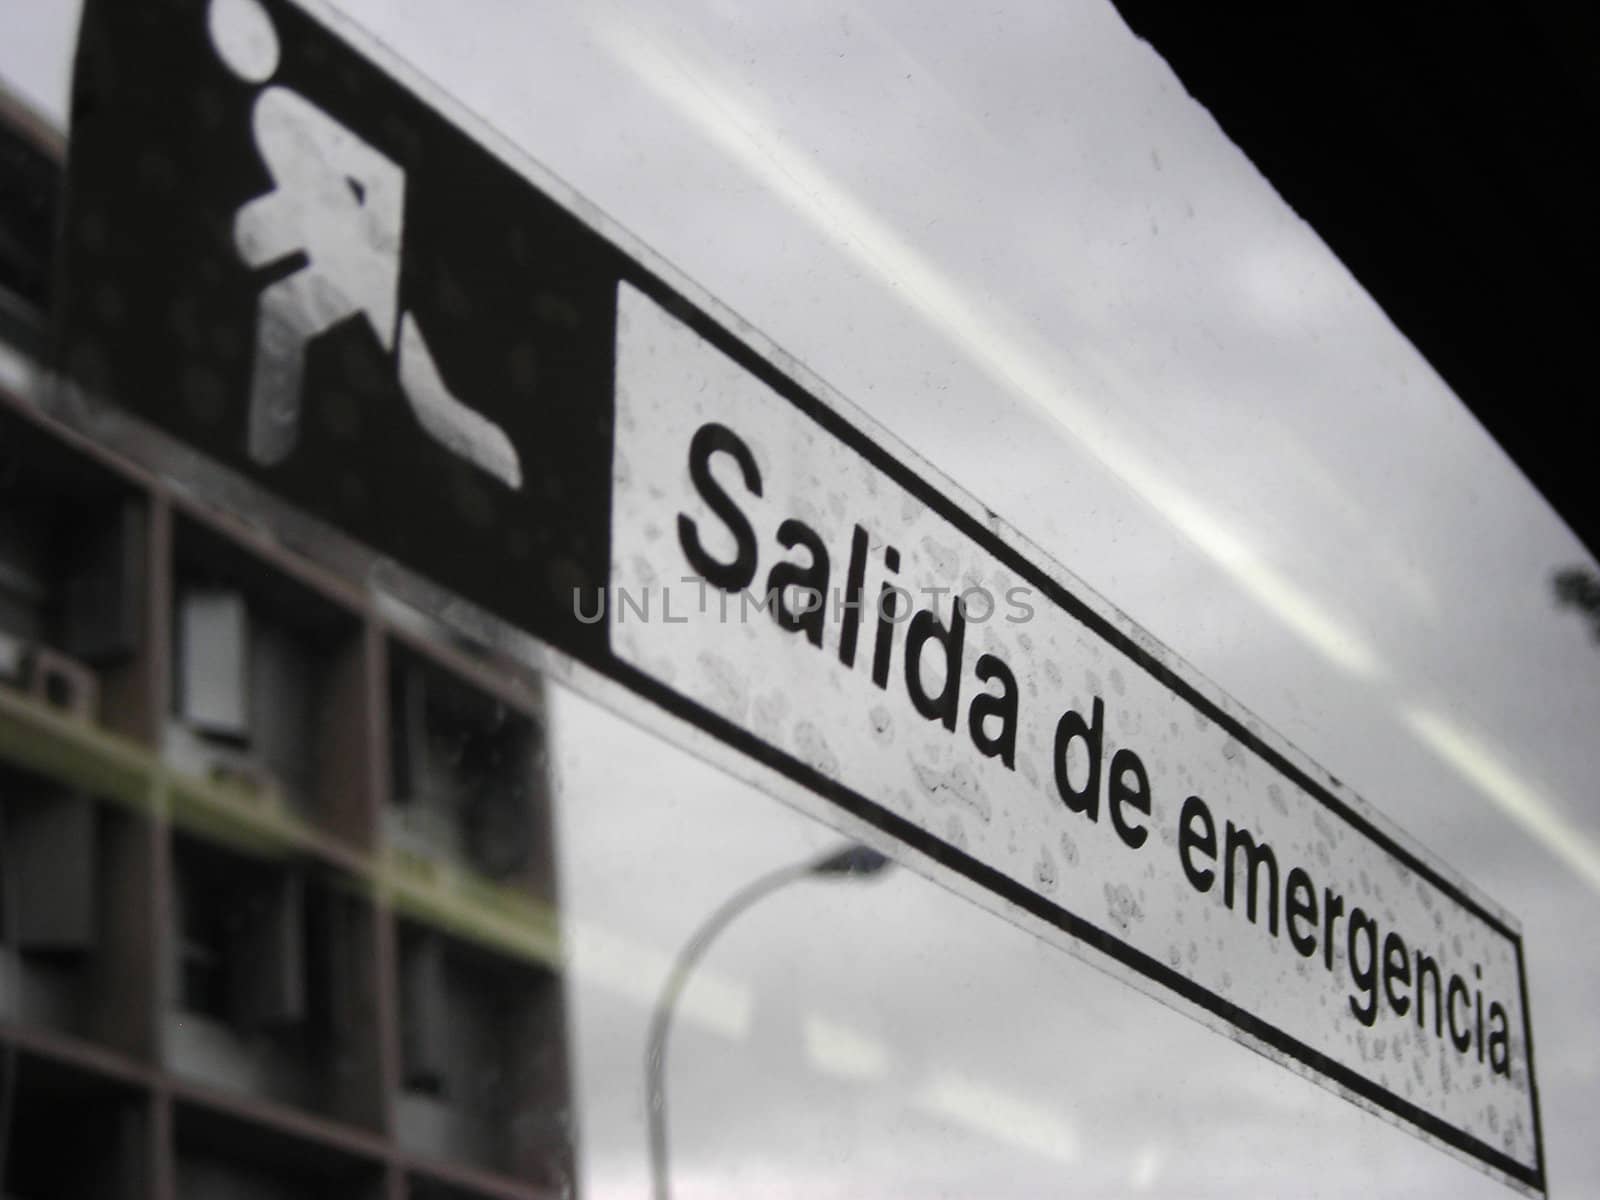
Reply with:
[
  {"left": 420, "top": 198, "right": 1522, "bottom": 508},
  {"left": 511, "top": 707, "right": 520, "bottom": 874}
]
[{"left": 1112, "top": 0, "right": 1600, "bottom": 566}]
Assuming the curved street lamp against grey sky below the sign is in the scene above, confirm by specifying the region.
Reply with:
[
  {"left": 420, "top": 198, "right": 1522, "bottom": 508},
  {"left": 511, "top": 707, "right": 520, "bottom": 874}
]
[{"left": 645, "top": 845, "right": 890, "bottom": 1200}]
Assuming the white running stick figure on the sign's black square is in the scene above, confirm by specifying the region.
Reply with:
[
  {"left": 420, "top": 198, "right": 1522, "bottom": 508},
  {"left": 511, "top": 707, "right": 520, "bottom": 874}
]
[{"left": 208, "top": 0, "right": 522, "bottom": 490}]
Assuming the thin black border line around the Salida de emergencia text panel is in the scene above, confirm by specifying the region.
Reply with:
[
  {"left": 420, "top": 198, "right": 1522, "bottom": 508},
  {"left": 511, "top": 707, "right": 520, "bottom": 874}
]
[{"left": 605, "top": 259, "right": 1546, "bottom": 1192}]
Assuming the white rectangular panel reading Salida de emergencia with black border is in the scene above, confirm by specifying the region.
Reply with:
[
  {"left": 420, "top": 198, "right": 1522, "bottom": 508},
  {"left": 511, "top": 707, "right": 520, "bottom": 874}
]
[{"left": 595, "top": 283, "right": 1538, "bottom": 1179}]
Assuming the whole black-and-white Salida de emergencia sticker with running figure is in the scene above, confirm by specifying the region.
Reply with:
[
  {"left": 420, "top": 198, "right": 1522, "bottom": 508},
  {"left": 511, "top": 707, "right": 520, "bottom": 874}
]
[{"left": 58, "top": 0, "right": 1544, "bottom": 1192}]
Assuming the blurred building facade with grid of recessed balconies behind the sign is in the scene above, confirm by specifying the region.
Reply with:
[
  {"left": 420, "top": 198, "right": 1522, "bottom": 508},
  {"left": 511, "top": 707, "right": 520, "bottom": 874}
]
[{"left": 0, "top": 86, "right": 574, "bottom": 1200}]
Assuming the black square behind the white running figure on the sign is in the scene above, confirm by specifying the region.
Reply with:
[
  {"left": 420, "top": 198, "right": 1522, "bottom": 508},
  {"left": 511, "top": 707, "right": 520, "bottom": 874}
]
[{"left": 58, "top": 0, "right": 619, "bottom": 658}]
